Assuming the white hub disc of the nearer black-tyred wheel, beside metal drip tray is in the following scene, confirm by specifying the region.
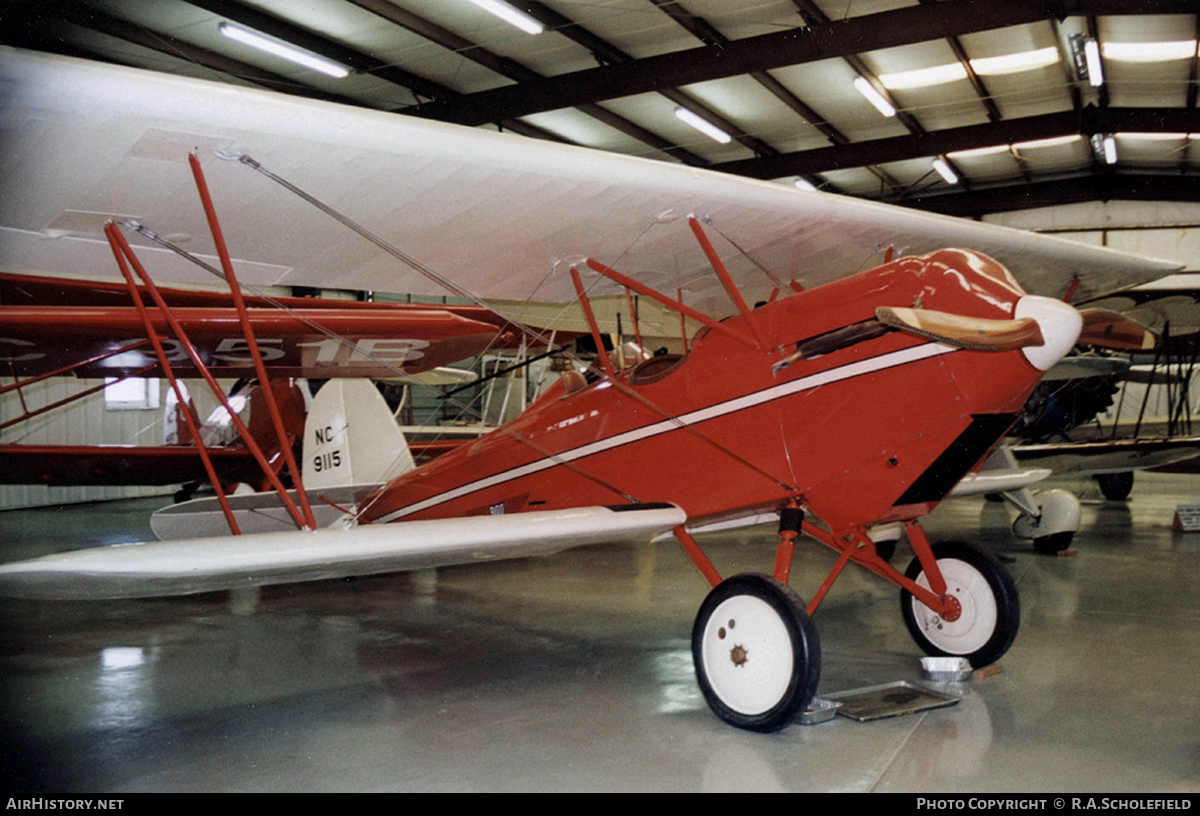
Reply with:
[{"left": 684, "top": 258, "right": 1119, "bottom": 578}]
[{"left": 702, "top": 595, "right": 793, "bottom": 715}]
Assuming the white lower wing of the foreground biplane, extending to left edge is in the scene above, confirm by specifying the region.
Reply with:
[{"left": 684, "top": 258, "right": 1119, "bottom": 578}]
[{"left": 0, "top": 504, "right": 686, "bottom": 600}]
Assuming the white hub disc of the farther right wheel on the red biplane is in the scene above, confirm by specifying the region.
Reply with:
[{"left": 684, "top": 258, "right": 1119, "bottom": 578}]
[{"left": 911, "top": 558, "right": 998, "bottom": 654}]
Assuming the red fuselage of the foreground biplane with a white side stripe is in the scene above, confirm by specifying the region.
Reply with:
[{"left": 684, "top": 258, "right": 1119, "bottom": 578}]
[{"left": 367, "top": 250, "right": 1043, "bottom": 530}]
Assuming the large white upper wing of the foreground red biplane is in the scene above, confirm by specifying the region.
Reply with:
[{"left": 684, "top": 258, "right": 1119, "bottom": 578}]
[{"left": 0, "top": 48, "right": 1176, "bottom": 312}]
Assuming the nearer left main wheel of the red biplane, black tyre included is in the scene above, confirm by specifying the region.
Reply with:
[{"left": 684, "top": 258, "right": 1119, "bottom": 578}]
[{"left": 691, "top": 575, "right": 821, "bottom": 731}]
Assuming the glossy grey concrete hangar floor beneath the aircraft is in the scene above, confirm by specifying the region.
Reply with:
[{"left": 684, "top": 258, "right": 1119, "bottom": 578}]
[{"left": 0, "top": 474, "right": 1200, "bottom": 793}]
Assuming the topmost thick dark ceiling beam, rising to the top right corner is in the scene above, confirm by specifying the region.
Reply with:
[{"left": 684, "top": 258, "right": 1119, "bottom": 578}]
[{"left": 408, "top": 0, "right": 1195, "bottom": 125}]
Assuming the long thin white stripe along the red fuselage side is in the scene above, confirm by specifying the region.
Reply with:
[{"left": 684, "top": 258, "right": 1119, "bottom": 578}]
[{"left": 376, "top": 343, "right": 956, "bottom": 522}]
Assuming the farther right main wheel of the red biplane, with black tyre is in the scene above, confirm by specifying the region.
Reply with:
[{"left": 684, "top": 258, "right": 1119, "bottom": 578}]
[{"left": 900, "top": 541, "right": 1021, "bottom": 668}]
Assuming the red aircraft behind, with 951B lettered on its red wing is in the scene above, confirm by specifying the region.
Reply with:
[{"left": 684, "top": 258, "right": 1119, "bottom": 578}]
[{"left": 0, "top": 268, "right": 526, "bottom": 490}]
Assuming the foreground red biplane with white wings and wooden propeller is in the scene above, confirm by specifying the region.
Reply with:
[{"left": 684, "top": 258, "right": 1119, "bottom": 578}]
[{"left": 0, "top": 47, "right": 1174, "bottom": 731}]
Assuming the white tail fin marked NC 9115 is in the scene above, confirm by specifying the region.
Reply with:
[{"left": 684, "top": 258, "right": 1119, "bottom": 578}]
[{"left": 302, "top": 379, "right": 413, "bottom": 490}]
